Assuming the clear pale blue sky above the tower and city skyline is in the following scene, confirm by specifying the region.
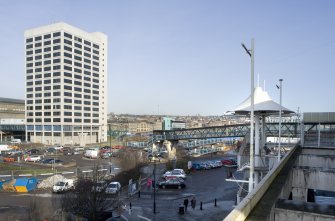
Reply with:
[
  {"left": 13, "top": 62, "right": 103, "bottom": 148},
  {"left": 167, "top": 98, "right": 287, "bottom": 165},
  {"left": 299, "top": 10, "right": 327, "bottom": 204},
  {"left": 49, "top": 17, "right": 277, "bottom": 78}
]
[{"left": 0, "top": 0, "right": 335, "bottom": 115}]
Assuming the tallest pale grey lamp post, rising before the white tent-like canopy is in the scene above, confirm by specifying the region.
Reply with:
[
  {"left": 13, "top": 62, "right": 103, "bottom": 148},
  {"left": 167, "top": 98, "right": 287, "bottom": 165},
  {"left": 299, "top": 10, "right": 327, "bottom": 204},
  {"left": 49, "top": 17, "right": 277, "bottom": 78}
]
[{"left": 242, "top": 38, "right": 255, "bottom": 193}]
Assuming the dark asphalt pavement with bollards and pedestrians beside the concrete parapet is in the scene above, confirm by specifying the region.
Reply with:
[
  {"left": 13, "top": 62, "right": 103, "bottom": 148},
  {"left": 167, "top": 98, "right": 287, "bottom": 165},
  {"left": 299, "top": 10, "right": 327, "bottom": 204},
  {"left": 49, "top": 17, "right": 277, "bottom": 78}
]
[{"left": 122, "top": 164, "right": 238, "bottom": 221}]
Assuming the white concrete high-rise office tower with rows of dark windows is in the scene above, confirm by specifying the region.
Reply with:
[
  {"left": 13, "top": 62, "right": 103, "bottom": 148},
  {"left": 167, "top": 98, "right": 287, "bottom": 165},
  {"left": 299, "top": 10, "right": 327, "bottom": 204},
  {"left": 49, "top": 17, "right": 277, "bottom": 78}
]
[{"left": 24, "top": 22, "right": 107, "bottom": 145}]
